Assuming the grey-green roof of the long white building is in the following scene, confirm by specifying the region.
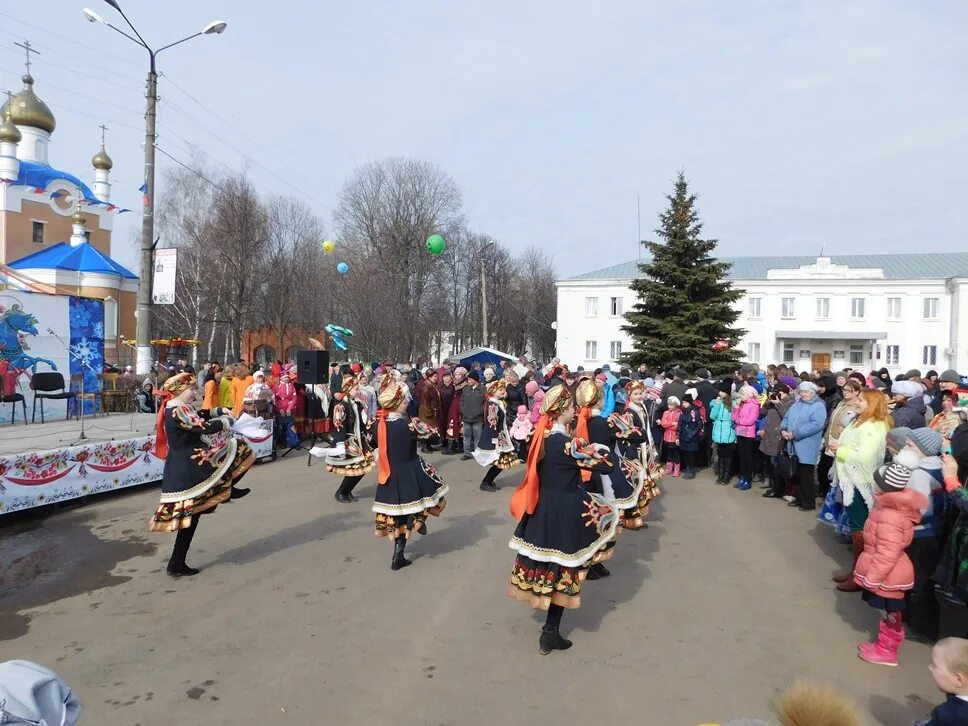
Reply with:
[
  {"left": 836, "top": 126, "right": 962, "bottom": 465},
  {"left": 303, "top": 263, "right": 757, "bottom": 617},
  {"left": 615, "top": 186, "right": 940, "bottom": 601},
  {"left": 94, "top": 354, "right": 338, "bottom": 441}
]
[{"left": 565, "top": 252, "right": 968, "bottom": 281}]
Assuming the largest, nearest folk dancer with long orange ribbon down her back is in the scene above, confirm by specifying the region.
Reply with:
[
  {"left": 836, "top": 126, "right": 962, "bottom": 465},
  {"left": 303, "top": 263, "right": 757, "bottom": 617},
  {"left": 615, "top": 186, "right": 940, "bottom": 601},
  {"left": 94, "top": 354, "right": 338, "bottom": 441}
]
[{"left": 509, "top": 385, "right": 618, "bottom": 655}]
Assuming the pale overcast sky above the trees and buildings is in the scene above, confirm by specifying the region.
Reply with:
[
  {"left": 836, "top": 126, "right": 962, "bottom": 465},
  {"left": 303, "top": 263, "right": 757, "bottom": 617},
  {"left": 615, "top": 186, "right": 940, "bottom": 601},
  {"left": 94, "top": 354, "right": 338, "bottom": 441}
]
[{"left": 0, "top": 0, "right": 968, "bottom": 276}]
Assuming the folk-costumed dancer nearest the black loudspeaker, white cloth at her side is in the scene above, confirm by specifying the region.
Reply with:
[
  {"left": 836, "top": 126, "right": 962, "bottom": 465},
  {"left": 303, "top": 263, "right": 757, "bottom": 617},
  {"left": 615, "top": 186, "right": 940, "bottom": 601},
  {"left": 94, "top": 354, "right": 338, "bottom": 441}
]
[{"left": 309, "top": 373, "right": 375, "bottom": 504}]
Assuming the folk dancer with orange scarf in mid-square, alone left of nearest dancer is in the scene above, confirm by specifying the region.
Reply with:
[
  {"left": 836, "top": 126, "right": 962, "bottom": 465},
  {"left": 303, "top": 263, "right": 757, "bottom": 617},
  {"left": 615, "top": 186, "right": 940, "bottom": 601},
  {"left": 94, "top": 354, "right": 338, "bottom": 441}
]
[{"left": 373, "top": 376, "right": 448, "bottom": 570}]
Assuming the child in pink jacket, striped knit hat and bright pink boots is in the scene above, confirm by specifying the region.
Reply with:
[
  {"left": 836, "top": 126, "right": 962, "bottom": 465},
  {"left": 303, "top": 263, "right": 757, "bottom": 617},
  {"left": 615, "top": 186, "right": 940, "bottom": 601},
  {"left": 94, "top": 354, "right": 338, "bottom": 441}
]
[{"left": 854, "top": 463, "right": 928, "bottom": 666}]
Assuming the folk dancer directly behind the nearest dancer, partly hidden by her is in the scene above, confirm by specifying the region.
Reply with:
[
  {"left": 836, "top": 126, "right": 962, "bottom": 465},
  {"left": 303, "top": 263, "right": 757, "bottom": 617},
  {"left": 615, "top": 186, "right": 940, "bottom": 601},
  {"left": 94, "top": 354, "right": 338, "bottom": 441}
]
[{"left": 575, "top": 379, "right": 643, "bottom": 536}]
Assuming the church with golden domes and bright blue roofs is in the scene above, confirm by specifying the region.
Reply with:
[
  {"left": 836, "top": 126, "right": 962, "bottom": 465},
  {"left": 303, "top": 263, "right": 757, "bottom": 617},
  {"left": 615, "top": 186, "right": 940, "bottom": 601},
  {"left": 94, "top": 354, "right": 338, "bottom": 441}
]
[{"left": 0, "top": 50, "right": 138, "bottom": 361}]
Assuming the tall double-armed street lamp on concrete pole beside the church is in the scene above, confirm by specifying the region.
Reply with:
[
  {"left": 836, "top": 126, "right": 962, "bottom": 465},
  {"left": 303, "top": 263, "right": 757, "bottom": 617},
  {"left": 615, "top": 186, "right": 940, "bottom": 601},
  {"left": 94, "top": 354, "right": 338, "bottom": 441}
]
[{"left": 84, "top": 5, "right": 228, "bottom": 375}]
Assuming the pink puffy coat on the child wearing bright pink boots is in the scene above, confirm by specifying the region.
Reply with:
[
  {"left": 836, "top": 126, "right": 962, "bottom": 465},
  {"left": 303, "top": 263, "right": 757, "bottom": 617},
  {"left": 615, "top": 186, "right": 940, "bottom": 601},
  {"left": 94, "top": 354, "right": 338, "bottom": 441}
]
[{"left": 854, "top": 488, "right": 928, "bottom": 600}]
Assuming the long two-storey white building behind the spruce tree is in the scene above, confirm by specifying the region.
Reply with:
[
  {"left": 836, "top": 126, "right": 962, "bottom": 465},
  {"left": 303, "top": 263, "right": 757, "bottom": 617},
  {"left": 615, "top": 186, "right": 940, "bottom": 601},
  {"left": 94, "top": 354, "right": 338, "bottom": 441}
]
[{"left": 557, "top": 252, "right": 968, "bottom": 375}]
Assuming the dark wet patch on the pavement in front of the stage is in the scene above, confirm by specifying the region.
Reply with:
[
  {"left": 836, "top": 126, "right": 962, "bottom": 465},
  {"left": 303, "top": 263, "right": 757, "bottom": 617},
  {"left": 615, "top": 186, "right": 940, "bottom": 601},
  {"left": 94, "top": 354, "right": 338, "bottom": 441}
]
[{"left": 0, "top": 512, "right": 158, "bottom": 641}]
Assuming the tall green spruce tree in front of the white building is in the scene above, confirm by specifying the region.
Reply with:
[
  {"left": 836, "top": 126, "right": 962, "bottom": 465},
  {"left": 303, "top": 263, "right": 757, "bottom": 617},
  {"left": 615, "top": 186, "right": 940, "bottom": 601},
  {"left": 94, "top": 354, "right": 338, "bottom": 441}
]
[{"left": 622, "top": 172, "right": 746, "bottom": 374}]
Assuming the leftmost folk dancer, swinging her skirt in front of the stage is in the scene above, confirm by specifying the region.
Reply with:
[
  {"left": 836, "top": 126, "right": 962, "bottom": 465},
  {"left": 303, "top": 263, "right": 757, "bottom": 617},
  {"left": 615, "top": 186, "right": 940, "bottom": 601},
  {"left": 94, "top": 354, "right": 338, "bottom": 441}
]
[{"left": 150, "top": 373, "right": 255, "bottom": 577}]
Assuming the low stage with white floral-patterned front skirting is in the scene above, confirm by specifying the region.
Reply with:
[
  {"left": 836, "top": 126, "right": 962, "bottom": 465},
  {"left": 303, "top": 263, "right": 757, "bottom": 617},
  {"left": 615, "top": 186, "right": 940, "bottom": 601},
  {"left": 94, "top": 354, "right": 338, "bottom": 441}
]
[{"left": 0, "top": 413, "right": 275, "bottom": 517}]
